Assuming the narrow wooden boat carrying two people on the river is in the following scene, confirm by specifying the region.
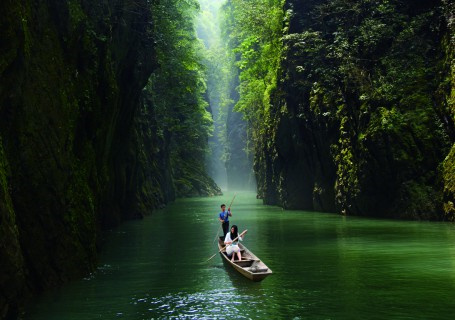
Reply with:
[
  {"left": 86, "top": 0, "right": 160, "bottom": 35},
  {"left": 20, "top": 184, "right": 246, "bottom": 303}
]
[{"left": 218, "top": 238, "right": 272, "bottom": 281}]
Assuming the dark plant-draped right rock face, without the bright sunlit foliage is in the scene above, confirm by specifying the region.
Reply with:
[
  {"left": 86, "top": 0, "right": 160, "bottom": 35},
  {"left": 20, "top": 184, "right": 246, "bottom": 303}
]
[{"left": 255, "top": 0, "right": 455, "bottom": 220}]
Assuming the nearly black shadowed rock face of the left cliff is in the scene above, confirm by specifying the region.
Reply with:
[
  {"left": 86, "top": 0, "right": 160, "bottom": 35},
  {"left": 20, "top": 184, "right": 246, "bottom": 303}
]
[{"left": 0, "top": 0, "right": 216, "bottom": 319}]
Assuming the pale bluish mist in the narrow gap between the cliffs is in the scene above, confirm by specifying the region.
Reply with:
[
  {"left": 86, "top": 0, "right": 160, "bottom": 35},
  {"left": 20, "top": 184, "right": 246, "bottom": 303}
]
[{"left": 196, "top": 0, "right": 256, "bottom": 190}]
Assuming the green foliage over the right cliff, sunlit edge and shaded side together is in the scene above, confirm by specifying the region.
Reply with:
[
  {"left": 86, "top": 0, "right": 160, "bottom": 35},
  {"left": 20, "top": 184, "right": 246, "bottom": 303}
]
[{"left": 223, "top": 0, "right": 453, "bottom": 218}]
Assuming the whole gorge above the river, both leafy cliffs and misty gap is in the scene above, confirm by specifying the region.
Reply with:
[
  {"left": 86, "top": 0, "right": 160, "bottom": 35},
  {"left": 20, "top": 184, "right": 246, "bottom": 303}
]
[{"left": 0, "top": 0, "right": 455, "bottom": 319}]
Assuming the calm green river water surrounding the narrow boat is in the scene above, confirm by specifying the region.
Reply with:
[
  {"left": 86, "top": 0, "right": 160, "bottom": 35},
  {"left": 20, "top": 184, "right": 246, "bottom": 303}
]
[{"left": 23, "top": 192, "right": 455, "bottom": 320}]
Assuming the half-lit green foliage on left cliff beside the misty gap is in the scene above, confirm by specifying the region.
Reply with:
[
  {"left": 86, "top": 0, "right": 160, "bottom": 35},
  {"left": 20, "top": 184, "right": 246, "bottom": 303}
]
[{"left": 147, "top": 0, "right": 218, "bottom": 195}]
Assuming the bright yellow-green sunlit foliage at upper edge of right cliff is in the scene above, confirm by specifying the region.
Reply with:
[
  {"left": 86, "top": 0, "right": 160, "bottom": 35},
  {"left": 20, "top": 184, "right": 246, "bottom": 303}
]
[{"left": 222, "top": 0, "right": 284, "bottom": 143}]
